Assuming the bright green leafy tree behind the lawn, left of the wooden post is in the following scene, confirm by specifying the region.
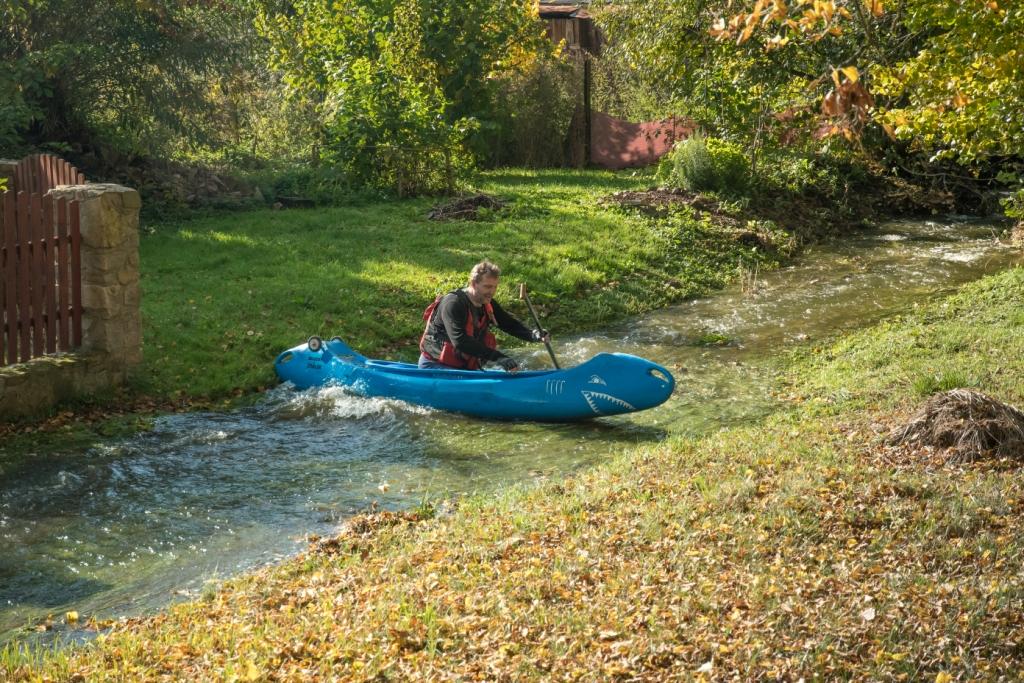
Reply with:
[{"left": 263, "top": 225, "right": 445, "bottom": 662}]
[{"left": 261, "top": 0, "right": 539, "bottom": 195}]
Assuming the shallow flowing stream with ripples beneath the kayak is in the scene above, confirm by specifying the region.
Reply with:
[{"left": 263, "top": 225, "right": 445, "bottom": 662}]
[{"left": 0, "top": 220, "right": 1021, "bottom": 641}]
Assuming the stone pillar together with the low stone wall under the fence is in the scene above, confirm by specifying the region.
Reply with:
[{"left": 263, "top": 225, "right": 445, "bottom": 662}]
[{"left": 0, "top": 179, "right": 142, "bottom": 420}]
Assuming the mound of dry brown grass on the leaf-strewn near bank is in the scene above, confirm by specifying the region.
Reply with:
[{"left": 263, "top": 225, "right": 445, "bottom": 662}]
[{"left": 888, "top": 389, "right": 1024, "bottom": 463}]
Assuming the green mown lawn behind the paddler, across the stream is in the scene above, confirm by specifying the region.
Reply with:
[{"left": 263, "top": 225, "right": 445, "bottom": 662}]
[{"left": 135, "top": 171, "right": 773, "bottom": 398}]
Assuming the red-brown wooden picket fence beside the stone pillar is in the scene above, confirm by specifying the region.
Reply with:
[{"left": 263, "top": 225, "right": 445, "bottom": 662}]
[{"left": 0, "top": 155, "right": 85, "bottom": 366}]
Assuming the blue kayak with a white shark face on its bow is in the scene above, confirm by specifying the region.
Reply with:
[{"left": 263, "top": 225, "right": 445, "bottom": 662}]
[{"left": 273, "top": 337, "right": 676, "bottom": 422}]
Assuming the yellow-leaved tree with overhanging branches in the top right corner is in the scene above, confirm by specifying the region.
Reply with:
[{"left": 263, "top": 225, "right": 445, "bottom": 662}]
[{"left": 712, "top": 0, "right": 1024, "bottom": 167}]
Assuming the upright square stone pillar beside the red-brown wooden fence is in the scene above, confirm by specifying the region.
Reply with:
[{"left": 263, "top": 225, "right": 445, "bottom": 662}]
[{"left": 49, "top": 183, "right": 142, "bottom": 383}]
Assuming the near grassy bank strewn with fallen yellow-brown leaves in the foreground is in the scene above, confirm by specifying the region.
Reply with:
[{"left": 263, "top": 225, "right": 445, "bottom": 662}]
[{"left": 0, "top": 270, "right": 1024, "bottom": 681}]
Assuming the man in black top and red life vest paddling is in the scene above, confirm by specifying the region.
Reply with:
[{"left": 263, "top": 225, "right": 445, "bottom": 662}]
[{"left": 419, "top": 261, "right": 550, "bottom": 373}]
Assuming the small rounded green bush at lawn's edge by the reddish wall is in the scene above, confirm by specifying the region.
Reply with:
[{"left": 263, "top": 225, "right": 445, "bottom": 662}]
[{"left": 657, "top": 133, "right": 751, "bottom": 196}]
